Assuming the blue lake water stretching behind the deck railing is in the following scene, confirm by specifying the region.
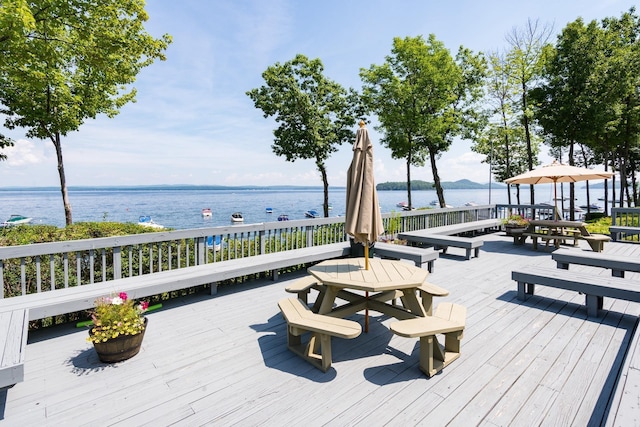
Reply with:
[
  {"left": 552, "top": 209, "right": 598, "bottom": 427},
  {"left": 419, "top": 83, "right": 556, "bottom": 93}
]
[{"left": 0, "top": 185, "right": 603, "bottom": 229}]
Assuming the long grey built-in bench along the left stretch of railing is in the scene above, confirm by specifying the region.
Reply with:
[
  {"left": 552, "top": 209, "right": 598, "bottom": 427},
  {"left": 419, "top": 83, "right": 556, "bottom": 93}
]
[{"left": 0, "top": 242, "right": 350, "bottom": 320}]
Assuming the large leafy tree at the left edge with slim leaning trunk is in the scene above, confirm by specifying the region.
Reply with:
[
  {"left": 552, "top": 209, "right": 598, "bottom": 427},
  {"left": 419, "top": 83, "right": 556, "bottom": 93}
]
[{"left": 0, "top": 0, "right": 171, "bottom": 225}]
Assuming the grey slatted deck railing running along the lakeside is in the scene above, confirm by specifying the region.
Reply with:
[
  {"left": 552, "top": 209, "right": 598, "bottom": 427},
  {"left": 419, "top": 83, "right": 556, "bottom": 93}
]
[{"left": 0, "top": 205, "right": 553, "bottom": 298}]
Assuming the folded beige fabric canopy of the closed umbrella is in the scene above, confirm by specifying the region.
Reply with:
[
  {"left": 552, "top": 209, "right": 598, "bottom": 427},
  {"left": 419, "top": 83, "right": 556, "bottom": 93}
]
[{"left": 345, "top": 123, "right": 384, "bottom": 245}]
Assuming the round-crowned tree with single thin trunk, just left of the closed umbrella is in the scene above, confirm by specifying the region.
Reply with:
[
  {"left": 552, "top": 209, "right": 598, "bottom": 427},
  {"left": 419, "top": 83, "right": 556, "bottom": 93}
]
[{"left": 247, "top": 54, "right": 356, "bottom": 217}]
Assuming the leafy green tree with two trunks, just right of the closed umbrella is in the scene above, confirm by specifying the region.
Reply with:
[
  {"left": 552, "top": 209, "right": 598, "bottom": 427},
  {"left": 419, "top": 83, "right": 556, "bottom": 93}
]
[{"left": 360, "top": 34, "right": 486, "bottom": 207}]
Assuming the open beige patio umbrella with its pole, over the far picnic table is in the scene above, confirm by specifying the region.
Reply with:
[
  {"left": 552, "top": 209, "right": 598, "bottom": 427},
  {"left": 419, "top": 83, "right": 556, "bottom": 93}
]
[{"left": 505, "top": 160, "right": 613, "bottom": 218}]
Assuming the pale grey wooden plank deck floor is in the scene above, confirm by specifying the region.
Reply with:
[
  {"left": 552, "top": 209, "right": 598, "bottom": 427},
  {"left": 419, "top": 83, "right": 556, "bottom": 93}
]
[{"left": 0, "top": 233, "right": 640, "bottom": 426}]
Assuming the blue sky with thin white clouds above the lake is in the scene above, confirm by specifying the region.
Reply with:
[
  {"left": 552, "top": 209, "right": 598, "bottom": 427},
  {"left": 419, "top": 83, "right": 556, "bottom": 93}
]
[{"left": 0, "top": 0, "right": 635, "bottom": 187}]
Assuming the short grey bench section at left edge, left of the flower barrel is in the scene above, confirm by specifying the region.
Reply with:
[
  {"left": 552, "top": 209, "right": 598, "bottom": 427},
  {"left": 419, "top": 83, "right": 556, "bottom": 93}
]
[{"left": 0, "top": 310, "right": 29, "bottom": 393}]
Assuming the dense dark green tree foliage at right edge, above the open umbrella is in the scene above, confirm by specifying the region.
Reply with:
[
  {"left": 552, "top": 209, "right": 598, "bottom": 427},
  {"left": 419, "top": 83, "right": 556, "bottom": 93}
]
[{"left": 531, "top": 9, "right": 640, "bottom": 210}]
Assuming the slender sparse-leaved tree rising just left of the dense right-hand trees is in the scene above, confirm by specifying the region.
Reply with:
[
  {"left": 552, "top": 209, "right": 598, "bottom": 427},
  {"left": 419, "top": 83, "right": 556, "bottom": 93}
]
[{"left": 506, "top": 20, "right": 553, "bottom": 205}]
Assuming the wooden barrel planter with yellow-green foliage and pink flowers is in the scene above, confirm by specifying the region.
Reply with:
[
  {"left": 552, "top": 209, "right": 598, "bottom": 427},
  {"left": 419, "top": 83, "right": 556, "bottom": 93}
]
[{"left": 87, "top": 292, "right": 149, "bottom": 363}]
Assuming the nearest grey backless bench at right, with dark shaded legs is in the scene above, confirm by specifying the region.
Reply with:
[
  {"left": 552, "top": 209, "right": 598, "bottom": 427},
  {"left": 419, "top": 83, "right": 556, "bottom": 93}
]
[{"left": 511, "top": 266, "right": 640, "bottom": 316}]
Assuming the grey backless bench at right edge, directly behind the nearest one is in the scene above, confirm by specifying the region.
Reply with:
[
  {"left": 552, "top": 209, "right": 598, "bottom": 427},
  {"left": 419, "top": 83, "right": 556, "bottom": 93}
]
[{"left": 551, "top": 249, "right": 640, "bottom": 277}]
